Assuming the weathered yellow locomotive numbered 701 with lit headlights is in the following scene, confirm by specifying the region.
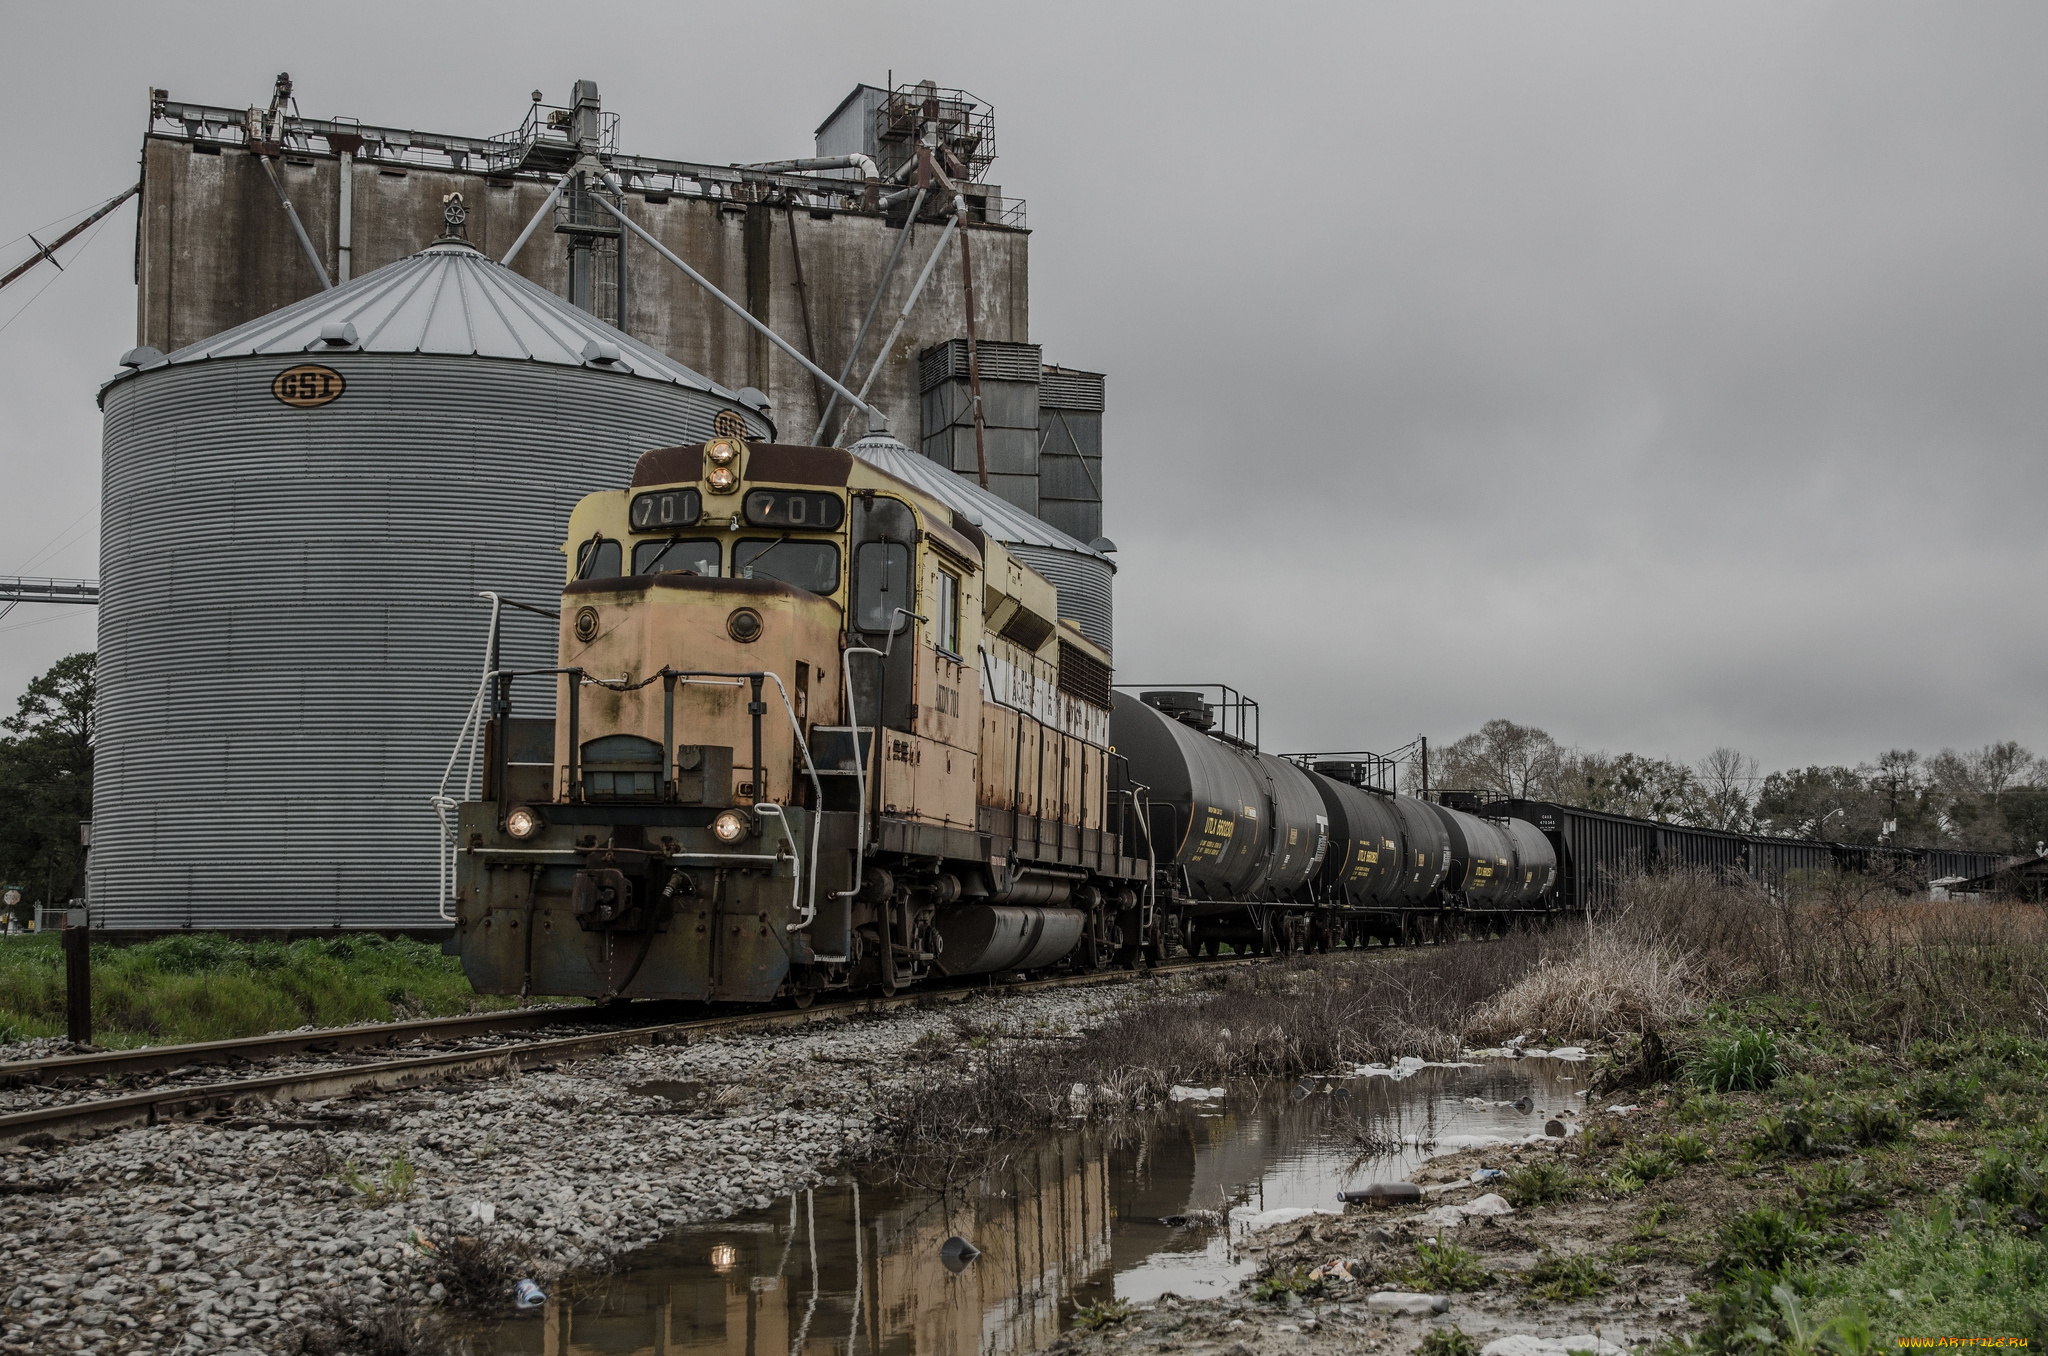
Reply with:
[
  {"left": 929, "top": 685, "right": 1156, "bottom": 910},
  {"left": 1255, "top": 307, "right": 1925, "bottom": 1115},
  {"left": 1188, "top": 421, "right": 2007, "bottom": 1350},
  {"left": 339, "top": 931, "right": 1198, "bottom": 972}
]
[{"left": 453, "top": 436, "right": 1145, "bottom": 1002}]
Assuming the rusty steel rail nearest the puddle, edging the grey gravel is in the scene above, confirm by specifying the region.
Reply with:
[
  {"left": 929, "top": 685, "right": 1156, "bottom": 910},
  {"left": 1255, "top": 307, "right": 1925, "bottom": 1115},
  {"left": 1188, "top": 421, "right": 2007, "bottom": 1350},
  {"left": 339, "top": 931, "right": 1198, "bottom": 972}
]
[{"left": 0, "top": 957, "right": 1270, "bottom": 1143}]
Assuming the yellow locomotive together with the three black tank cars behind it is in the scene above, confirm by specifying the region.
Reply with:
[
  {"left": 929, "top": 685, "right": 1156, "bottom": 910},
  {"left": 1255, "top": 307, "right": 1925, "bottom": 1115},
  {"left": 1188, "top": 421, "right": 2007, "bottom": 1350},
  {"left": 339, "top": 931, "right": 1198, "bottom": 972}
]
[{"left": 444, "top": 426, "right": 1556, "bottom": 1006}]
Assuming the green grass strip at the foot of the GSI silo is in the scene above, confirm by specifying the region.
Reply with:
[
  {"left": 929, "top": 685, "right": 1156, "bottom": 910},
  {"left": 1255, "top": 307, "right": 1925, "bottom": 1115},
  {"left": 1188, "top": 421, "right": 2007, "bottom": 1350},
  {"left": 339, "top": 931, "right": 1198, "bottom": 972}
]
[{"left": 0, "top": 932, "right": 518, "bottom": 1049}]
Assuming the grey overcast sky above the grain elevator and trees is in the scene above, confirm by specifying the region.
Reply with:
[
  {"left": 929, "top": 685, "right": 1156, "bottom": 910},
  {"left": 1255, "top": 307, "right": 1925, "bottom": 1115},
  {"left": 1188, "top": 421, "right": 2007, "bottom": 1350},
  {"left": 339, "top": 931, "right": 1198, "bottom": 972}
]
[{"left": 0, "top": 0, "right": 2048, "bottom": 768}]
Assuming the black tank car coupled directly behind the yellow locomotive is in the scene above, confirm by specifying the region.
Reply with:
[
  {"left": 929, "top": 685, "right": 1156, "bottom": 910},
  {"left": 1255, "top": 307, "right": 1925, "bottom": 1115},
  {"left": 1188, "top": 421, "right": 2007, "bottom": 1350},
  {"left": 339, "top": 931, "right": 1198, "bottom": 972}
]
[{"left": 1110, "top": 692, "right": 1329, "bottom": 903}]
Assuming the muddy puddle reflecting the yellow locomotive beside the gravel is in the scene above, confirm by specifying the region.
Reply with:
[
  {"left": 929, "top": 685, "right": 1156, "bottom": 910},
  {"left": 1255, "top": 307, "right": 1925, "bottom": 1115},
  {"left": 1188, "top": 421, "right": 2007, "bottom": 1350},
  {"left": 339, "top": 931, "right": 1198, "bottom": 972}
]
[{"left": 457, "top": 1059, "right": 1583, "bottom": 1356}]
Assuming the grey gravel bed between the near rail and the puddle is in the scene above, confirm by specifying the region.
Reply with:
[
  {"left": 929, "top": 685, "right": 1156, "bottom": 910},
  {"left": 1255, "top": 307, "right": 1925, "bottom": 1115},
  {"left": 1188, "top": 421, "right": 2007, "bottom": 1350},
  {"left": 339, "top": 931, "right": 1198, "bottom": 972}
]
[{"left": 0, "top": 981, "right": 1138, "bottom": 1354}]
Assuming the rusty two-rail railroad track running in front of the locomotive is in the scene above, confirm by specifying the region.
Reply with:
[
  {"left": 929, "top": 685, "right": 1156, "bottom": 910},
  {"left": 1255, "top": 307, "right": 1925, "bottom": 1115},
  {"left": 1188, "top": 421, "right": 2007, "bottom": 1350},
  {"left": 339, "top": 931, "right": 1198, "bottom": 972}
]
[{"left": 0, "top": 957, "right": 1260, "bottom": 1147}]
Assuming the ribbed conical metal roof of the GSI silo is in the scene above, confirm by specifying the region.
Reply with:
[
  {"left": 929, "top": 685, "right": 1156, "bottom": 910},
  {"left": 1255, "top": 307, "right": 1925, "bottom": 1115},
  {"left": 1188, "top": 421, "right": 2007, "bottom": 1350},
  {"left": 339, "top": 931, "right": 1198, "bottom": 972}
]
[{"left": 100, "top": 240, "right": 739, "bottom": 401}]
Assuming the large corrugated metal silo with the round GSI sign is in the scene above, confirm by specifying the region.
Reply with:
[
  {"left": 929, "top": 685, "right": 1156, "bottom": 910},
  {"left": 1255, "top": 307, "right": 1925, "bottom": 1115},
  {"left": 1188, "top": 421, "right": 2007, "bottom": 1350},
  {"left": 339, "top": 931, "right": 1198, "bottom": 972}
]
[{"left": 92, "top": 240, "right": 770, "bottom": 928}]
